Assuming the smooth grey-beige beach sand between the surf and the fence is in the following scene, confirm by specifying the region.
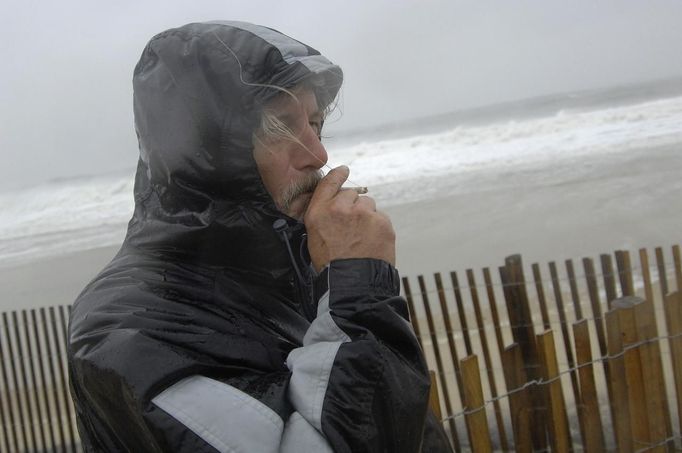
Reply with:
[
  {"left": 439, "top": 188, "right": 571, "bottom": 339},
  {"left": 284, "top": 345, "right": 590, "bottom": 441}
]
[{"left": 0, "top": 147, "right": 682, "bottom": 311}]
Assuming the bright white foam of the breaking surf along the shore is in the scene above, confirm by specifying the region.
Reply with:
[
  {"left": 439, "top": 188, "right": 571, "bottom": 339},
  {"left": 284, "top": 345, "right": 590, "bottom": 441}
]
[{"left": 0, "top": 97, "right": 682, "bottom": 266}]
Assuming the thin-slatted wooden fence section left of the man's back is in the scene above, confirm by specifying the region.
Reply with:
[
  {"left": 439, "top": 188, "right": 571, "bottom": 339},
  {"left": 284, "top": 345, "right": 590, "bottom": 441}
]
[{"left": 0, "top": 306, "right": 82, "bottom": 453}]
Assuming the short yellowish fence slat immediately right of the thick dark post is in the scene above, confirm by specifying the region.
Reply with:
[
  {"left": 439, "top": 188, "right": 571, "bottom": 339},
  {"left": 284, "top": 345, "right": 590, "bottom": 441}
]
[{"left": 537, "top": 330, "right": 572, "bottom": 452}]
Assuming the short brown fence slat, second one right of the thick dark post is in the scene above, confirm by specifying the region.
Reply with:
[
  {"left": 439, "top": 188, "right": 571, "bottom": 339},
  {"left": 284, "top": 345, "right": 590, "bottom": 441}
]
[{"left": 573, "top": 319, "right": 606, "bottom": 453}]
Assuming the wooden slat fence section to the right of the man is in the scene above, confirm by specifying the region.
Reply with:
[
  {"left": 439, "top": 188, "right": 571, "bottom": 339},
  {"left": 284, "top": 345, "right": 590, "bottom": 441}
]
[{"left": 403, "top": 245, "right": 682, "bottom": 452}]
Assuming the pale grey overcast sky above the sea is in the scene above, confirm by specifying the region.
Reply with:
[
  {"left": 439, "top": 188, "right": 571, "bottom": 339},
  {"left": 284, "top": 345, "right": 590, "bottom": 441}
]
[{"left": 0, "top": 0, "right": 682, "bottom": 190}]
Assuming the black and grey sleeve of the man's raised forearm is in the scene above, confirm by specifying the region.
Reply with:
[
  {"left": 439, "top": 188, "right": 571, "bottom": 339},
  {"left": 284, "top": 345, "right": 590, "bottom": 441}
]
[{"left": 287, "top": 259, "right": 429, "bottom": 452}]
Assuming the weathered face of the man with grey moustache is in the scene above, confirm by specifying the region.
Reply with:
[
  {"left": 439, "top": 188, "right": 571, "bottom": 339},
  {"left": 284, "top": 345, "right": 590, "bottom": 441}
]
[{"left": 253, "top": 90, "right": 327, "bottom": 220}]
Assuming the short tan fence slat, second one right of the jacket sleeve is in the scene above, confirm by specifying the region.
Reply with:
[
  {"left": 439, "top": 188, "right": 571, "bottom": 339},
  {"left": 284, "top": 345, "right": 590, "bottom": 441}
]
[{"left": 460, "top": 355, "right": 493, "bottom": 453}]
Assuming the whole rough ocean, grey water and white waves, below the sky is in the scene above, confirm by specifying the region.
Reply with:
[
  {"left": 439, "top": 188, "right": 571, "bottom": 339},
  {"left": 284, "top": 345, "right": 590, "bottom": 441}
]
[{"left": 0, "top": 81, "right": 682, "bottom": 267}]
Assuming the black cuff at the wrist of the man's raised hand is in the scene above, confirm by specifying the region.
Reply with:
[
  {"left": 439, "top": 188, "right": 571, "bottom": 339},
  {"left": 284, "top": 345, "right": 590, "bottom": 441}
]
[{"left": 313, "top": 258, "right": 400, "bottom": 300}]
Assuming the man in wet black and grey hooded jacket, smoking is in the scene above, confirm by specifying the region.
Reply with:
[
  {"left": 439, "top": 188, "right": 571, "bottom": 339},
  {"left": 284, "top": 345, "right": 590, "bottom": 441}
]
[{"left": 69, "top": 22, "right": 449, "bottom": 452}]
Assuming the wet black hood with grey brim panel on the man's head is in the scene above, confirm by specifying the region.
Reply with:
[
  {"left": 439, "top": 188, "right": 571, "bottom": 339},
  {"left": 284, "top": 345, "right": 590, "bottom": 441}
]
[{"left": 124, "top": 22, "right": 343, "bottom": 278}]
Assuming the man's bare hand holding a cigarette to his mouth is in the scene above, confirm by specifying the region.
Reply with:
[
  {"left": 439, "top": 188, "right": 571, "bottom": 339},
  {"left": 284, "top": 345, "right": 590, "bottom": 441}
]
[{"left": 303, "top": 166, "right": 395, "bottom": 272}]
